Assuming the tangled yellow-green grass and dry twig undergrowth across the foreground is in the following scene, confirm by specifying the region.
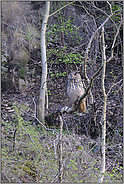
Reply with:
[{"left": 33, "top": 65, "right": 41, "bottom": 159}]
[{"left": 1, "top": 104, "right": 123, "bottom": 183}]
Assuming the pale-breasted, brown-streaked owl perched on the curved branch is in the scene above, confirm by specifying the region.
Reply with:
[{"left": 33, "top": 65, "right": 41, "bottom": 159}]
[{"left": 67, "top": 71, "right": 86, "bottom": 113}]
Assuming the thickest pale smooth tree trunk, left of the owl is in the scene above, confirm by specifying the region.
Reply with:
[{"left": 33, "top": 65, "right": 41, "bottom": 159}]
[{"left": 38, "top": 1, "right": 50, "bottom": 122}]
